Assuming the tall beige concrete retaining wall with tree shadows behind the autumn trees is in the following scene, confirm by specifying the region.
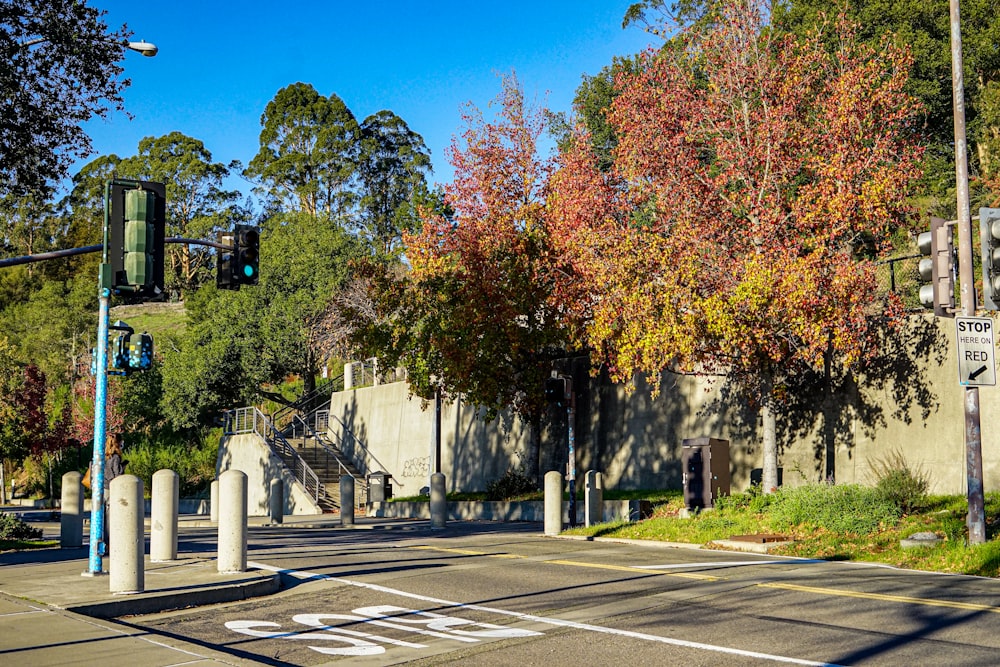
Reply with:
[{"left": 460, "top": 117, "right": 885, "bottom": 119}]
[{"left": 330, "top": 315, "right": 1000, "bottom": 496}]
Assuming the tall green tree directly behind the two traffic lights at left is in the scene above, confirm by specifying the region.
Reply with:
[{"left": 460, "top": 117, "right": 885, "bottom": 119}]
[{"left": 118, "top": 132, "right": 246, "bottom": 298}]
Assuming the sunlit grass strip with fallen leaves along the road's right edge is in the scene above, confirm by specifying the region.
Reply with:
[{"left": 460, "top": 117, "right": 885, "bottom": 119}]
[{"left": 565, "top": 485, "right": 1000, "bottom": 577}]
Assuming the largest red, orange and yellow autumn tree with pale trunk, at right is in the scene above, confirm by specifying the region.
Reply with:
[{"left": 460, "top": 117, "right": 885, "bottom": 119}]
[{"left": 550, "top": 0, "right": 921, "bottom": 491}]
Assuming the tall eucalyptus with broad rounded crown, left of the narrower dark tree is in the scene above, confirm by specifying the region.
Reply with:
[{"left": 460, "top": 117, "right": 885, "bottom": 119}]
[{"left": 244, "top": 83, "right": 360, "bottom": 216}]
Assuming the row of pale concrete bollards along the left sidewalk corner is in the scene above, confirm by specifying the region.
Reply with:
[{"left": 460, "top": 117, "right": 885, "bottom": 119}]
[{"left": 59, "top": 470, "right": 252, "bottom": 593}]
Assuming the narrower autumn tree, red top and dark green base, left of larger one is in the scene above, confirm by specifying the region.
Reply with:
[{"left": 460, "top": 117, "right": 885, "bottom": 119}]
[{"left": 357, "top": 77, "right": 566, "bottom": 480}]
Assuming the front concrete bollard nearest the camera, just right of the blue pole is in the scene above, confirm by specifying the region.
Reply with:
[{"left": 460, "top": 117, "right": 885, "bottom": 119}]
[{"left": 108, "top": 475, "right": 146, "bottom": 593}]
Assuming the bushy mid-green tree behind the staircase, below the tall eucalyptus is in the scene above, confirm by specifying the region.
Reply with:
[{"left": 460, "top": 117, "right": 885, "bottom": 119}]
[{"left": 163, "top": 213, "right": 361, "bottom": 428}]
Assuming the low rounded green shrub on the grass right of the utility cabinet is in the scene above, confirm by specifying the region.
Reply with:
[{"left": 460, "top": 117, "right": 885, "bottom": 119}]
[{"left": 767, "top": 484, "right": 902, "bottom": 535}]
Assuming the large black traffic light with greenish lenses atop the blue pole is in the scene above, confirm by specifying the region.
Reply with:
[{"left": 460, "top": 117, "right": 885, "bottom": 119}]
[{"left": 105, "top": 179, "right": 167, "bottom": 299}]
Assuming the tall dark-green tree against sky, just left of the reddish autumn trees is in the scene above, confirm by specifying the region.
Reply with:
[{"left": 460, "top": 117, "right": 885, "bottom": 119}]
[{"left": 358, "top": 110, "right": 431, "bottom": 257}]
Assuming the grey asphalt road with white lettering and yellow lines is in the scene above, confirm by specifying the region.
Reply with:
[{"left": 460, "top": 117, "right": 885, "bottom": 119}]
[{"left": 122, "top": 524, "right": 1000, "bottom": 667}]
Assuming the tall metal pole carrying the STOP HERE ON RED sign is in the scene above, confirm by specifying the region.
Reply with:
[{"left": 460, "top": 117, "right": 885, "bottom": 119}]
[{"left": 949, "top": 0, "right": 986, "bottom": 544}]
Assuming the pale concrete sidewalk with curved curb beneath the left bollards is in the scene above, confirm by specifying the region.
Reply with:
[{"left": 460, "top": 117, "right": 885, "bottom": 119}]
[{"left": 0, "top": 507, "right": 436, "bottom": 667}]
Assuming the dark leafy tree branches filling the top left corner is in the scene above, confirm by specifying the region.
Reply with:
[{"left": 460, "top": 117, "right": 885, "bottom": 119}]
[{"left": 0, "top": 0, "right": 131, "bottom": 197}]
